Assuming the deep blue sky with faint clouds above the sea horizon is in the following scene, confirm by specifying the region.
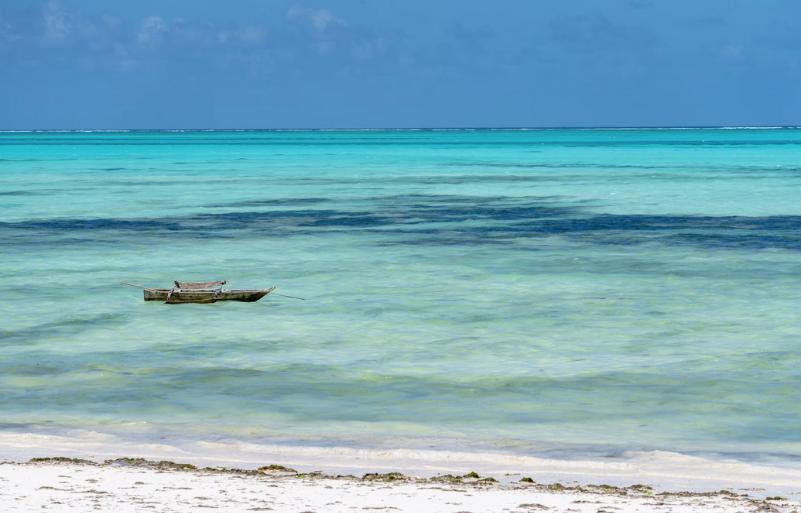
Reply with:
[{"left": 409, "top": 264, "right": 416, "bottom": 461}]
[{"left": 0, "top": 0, "right": 801, "bottom": 129}]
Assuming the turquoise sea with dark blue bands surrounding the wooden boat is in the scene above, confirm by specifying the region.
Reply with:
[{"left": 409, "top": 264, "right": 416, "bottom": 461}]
[{"left": 0, "top": 129, "right": 801, "bottom": 459}]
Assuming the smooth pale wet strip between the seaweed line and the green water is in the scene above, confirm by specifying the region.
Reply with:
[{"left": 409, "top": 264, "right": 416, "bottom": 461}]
[{"left": 0, "top": 431, "right": 801, "bottom": 499}]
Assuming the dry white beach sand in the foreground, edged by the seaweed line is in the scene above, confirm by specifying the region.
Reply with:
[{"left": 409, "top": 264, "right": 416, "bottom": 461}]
[{"left": 0, "top": 458, "right": 801, "bottom": 513}]
